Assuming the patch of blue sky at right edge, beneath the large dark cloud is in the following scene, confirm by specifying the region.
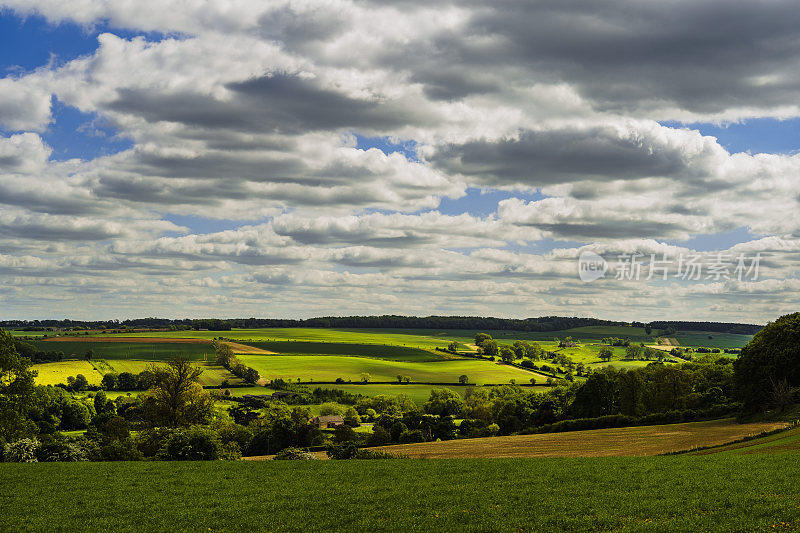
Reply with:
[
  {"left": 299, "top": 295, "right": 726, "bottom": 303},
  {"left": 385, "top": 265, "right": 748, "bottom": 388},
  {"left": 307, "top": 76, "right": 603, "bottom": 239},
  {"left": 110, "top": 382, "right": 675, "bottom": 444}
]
[{"left": 661, "top": 118, "right": 800, "bottom": 154}]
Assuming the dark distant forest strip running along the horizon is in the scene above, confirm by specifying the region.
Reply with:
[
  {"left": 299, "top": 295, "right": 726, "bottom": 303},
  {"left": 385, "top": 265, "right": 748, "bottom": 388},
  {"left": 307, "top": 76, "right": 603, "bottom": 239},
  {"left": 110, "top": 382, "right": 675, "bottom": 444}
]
[{"left": 0, "top": 315, "right": 763, "bottom": 335}]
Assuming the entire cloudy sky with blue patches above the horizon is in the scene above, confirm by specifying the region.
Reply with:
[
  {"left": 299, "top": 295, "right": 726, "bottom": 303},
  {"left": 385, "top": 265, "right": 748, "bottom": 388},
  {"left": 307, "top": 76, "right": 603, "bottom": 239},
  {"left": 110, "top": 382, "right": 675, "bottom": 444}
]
[{"left": 0, "top": 0, "right": 800, "bottom": 323}]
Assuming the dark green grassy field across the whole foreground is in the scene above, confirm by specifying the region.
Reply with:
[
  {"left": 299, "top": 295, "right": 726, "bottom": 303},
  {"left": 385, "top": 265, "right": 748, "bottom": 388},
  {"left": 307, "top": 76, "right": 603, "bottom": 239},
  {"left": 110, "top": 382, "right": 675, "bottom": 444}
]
[{"left": 0, "top": 454, "right": 800, "bottom": 532}]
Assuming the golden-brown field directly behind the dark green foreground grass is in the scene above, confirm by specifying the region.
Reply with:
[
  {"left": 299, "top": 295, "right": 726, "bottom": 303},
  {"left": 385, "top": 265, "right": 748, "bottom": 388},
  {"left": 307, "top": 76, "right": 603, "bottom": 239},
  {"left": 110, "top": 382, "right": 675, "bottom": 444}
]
[{"left": 373, "top": 418, "right": 788, "bottom": 459}]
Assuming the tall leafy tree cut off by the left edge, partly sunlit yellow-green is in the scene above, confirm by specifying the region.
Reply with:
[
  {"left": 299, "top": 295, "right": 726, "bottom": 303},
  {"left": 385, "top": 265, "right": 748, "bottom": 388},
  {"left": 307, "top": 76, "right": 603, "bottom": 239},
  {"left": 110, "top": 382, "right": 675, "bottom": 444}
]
[{"left": 0, "top": 329, "right": 38, "bottom": 444}]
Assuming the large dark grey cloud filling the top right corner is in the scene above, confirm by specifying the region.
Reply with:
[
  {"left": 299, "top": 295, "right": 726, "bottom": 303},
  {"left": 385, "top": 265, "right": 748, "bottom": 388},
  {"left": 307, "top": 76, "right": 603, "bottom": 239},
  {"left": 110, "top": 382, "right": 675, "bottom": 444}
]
[{"left": 383, "top": 0, "right": 800, "bottom": 114}]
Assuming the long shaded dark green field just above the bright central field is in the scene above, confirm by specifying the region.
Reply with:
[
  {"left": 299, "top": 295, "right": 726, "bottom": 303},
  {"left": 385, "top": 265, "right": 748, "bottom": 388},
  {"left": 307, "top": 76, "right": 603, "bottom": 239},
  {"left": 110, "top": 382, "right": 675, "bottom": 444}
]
[{"left": 242, "top": 341, "right": 449, "bottom": 362}]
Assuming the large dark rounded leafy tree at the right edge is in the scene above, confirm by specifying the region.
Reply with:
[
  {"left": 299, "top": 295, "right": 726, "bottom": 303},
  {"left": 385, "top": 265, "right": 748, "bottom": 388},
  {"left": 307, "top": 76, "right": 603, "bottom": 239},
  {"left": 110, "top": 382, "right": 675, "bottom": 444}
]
[{"left": 734, "top": 313, "right": 800, "bottom": 411}]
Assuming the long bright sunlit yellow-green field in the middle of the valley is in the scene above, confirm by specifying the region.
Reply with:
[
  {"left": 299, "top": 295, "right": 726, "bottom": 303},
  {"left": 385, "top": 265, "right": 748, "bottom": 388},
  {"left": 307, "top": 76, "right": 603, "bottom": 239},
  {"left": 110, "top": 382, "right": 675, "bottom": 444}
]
[{"left": 237, "top": 355, "right": 547, "bottom": 385}]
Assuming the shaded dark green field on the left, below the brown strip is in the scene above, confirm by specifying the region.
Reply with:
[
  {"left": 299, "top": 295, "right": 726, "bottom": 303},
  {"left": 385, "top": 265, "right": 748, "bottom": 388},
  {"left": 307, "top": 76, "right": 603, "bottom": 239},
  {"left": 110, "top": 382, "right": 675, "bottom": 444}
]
[{"left": 29, "top": 340, "right": 214, "bottom": 361}]
